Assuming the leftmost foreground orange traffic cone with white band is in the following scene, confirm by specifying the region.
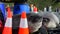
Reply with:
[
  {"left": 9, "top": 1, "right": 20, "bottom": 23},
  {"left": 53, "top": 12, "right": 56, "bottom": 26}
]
[{"left": 2, "top": 6, "right": 12, "bottom": 34}]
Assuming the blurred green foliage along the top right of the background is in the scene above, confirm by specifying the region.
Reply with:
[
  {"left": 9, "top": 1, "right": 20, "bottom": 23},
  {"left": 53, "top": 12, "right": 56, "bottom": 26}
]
[{"left": 28, "top": 0, "right": 60, "bottom": 10}]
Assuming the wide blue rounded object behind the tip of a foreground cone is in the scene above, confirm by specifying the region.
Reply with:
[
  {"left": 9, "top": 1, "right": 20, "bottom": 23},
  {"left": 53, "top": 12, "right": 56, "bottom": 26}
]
[{"left": 13, "top": 3, "right": 30, "bottom": 15}]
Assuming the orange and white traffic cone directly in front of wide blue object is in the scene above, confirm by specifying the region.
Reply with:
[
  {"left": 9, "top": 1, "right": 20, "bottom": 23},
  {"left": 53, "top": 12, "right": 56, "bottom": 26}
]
[{"left": 18, "top": 12, "right": 29, "bottom": 34}]
